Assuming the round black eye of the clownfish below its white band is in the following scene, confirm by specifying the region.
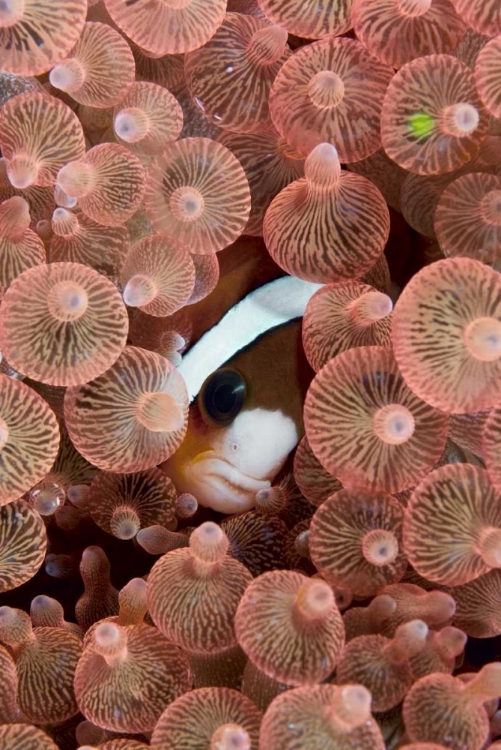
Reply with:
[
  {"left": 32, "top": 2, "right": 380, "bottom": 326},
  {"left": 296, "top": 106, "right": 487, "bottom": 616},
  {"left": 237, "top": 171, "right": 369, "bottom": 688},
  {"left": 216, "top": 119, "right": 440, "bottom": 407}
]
[{"left": 199, "top": 369, "right": 247, "bottom": 427}]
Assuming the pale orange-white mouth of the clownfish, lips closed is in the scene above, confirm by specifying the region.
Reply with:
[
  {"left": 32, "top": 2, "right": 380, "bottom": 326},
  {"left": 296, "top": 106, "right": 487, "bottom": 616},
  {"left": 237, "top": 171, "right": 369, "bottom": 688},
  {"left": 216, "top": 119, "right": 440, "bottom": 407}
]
[{"left": 192, "top": 451, "right": 271, "bottom": 499}]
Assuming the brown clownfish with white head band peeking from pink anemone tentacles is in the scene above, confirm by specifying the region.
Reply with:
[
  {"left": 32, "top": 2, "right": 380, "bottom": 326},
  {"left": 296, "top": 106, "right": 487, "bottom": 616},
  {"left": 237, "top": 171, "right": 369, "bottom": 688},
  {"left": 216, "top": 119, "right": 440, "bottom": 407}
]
[{"left": 162, "top": 241, "right": 321, "bottom": 514}]
